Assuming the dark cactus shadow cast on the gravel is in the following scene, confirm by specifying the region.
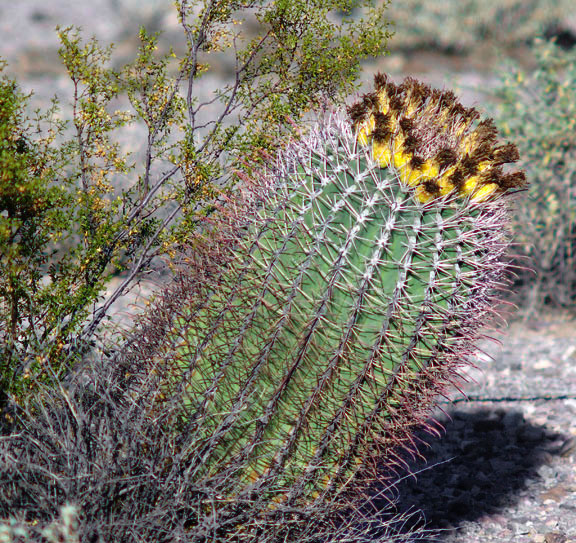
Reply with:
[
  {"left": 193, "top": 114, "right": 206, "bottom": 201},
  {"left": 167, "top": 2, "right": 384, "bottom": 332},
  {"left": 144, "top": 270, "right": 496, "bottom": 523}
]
[{"left": 372, "top": 409, "right": 565, "bottom": 542}]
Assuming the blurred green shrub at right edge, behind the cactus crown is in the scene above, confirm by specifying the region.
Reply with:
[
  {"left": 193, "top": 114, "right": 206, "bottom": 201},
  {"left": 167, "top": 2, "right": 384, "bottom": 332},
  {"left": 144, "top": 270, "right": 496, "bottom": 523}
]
[{"left": 494, "top": 41, "right": 576, "bottom": 314}]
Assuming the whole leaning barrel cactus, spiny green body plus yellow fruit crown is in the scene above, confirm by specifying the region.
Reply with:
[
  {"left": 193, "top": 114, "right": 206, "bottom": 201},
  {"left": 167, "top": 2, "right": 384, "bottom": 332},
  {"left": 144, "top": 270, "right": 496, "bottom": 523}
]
[{"left": 57, "top": 76, "right": 524, "bottom": 541}]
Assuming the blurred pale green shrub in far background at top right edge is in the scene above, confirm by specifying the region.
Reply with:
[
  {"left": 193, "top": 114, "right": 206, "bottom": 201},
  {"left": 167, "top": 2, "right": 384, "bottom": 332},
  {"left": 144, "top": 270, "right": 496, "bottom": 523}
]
[{"left": 389, "top": 0, "right": 573, "bottom": 52}]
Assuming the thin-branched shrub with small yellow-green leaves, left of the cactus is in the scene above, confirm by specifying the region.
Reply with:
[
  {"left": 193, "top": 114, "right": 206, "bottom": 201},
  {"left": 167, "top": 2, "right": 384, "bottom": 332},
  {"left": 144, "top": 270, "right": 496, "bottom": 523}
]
[{"left": 0, "top": 0, "right": 388, "bottom": 410}]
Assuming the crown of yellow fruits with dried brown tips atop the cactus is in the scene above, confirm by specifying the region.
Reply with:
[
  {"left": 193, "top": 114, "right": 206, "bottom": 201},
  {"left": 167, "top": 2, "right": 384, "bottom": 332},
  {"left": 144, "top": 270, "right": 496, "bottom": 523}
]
[{"left": 348, "top": 74, "right": 525, "bottom": 202}]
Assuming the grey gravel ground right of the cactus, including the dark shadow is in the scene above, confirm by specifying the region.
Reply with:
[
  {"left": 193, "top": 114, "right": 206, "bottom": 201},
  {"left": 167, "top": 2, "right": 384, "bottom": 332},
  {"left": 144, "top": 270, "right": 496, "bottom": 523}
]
[{"left": 382, "top": 313, "right": 576, "bottom": 543}]
